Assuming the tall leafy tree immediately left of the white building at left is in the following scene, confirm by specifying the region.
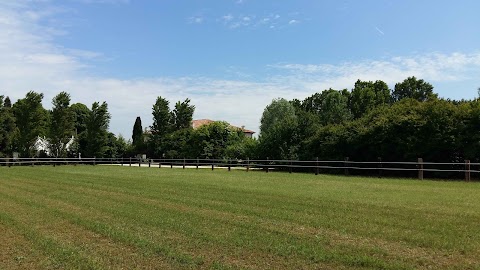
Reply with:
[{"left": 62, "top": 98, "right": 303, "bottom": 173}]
[{"left": 13, "top": 91, "right": 48, "bottom": 157}]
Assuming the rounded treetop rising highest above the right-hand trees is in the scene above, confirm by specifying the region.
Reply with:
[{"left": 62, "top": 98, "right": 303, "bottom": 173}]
[{"left": 392, "top": 76, "right": 437, "bottom": 102}]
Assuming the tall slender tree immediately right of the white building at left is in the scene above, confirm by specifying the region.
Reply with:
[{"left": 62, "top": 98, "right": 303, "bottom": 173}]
[{"left": 49, "top": 92, "right": 75, "bottom": 157}]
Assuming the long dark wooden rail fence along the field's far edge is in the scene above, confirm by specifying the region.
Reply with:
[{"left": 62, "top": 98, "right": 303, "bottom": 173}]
[{"left": 0, "top": 158, "right": 480, "bottom": 181}]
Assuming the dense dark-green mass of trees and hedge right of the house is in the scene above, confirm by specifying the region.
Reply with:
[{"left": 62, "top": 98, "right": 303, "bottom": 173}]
[{"left": 257, "top": 77, "right": 480, "bottom": 162}]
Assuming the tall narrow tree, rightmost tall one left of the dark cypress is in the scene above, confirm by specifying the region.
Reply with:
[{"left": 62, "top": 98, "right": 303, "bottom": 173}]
[{"left": 85, "top": 102, "right": 110, "bottom": 157}]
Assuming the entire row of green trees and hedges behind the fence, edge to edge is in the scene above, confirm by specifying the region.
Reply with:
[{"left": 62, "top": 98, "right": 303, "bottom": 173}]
[{"left": 0, "top": 77, "right": 480, "bottom": 162}]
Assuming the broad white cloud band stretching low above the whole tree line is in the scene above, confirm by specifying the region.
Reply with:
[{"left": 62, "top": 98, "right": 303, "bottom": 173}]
[{"left": 0, "top": 2, "right": 480, "bottom": 137}]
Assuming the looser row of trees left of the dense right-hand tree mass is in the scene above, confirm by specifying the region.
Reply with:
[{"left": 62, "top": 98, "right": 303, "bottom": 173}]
[{"left": 0, "top": 91, "right": 256, "bottom": 158}]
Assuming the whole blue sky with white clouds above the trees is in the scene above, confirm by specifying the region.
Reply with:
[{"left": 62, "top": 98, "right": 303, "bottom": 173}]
[{"left": 0, "top": 0, "right": 480, "bottom": 138}]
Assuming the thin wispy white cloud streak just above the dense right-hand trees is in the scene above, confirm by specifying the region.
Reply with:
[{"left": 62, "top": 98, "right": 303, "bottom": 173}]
[{"left": 270, "top": 52, "right": 480, "bottom": 90}]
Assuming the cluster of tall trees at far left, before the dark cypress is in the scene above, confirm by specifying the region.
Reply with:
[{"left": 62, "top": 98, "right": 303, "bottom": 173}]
[{"left": 0, "top": 91, "right": 116, "bottom": 157}]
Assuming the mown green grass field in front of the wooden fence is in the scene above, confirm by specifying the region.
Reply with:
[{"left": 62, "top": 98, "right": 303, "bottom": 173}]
[{"left": 0, "top": 166, "right": 480, "bottom": 269}]
